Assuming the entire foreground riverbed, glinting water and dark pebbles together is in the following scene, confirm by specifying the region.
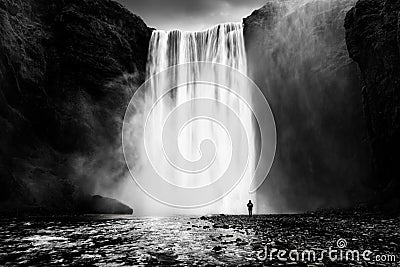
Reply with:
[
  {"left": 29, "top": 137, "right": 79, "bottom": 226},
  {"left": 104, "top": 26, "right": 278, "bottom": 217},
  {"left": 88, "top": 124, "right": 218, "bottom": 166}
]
[{"left": 0, "top": 212, "right": 400, "bottom": 266}]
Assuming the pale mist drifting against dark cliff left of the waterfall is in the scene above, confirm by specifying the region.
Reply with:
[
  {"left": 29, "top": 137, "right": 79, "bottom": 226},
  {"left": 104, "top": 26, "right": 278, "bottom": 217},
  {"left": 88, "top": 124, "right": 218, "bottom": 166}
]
[{"left": 68, "top": 72, "right": 141, "bottom": 203}]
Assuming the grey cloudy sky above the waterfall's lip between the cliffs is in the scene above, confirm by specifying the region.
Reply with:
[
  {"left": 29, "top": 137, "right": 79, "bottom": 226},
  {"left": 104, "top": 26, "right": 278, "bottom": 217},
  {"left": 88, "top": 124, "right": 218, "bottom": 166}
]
[{"left": 117, "top": 0, "right": 266, "bottom": 31}]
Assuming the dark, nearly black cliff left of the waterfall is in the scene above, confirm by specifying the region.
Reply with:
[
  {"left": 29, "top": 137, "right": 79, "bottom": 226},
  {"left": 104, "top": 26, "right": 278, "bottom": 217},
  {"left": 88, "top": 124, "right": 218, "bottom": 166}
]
[{"left": 0, "top": 0, "right": 151, "bottom": 214}]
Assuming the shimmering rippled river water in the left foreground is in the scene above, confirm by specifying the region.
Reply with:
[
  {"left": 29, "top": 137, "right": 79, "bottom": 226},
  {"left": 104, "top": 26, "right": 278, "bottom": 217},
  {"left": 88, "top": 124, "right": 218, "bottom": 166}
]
[{"left": 0, "top": 215, "right": 256, "bottom": 266}]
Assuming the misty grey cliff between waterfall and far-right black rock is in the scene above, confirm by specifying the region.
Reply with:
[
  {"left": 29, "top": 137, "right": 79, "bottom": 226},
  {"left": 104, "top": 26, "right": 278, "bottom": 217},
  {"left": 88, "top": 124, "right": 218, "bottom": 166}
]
[{"left": 244, "top": 0, "right": 371, "bottom": 212}]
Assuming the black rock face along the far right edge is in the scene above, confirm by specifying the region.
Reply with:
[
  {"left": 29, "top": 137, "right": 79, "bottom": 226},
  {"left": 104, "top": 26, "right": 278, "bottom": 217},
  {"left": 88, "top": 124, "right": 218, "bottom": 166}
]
[{"left": 345, "top": 0, "right": 400, "bottom": 210}]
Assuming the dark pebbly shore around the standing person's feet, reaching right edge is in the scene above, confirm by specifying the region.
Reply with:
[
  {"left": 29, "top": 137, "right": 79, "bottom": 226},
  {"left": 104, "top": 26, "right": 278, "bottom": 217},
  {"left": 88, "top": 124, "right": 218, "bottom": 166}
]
[{"left": 207, "top": 211, "right": 400, "bottom": 266}]
